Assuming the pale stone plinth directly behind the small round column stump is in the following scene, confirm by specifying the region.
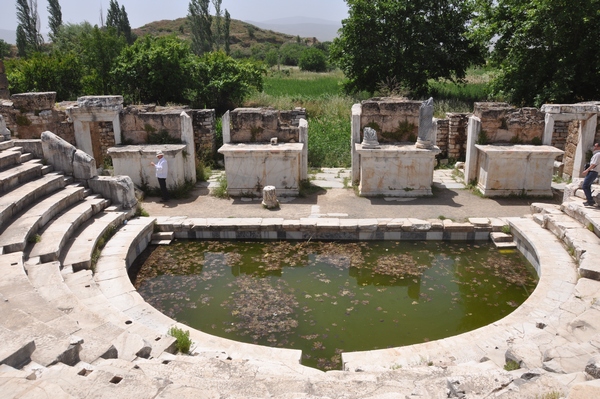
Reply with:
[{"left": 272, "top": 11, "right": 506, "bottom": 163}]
[{"left": 219, "top": 143, "right": 306, "bottom": 197}]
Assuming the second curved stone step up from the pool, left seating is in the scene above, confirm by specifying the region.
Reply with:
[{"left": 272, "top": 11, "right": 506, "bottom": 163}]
[{"left": 27, "top": 195, "right": 110, "bottom": 263}]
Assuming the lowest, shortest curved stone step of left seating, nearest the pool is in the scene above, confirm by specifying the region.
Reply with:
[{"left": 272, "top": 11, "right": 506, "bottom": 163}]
[{"left": 61, "top": 212, "right": 126, "bottom": 272}]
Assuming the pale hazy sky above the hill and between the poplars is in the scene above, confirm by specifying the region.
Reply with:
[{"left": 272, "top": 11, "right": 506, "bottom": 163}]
[{"left": 0, "top": 0, "right": 348, "bottom": 32}]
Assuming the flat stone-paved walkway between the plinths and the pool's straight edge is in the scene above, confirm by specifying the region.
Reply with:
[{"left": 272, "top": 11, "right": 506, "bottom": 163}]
[{"left": 142, "top": 168, "right": 562, "bottom": 222}]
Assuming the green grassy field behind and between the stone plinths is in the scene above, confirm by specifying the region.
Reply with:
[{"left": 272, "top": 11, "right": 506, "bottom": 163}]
[{"left": 244, "top": 68, "right": 493, "bottom": 168}]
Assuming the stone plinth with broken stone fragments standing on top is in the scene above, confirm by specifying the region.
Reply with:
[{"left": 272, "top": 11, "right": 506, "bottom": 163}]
[{"left": 354, "top": 143, "right": 440, "bottom": 197}]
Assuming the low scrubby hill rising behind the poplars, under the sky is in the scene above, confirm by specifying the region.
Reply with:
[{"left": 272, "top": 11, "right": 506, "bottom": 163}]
[{"left": 132, "top": 18, "right": 315, "bottom": 55}]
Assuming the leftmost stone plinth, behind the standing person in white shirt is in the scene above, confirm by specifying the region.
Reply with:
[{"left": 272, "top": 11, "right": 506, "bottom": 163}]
[{"left": 108, "top": 144, "right": 188, "bottom": 189}]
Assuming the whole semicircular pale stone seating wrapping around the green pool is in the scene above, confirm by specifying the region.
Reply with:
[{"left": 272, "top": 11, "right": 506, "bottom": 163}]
[{"left": 0, "top": 138, "right": 600, "bottom": 398}]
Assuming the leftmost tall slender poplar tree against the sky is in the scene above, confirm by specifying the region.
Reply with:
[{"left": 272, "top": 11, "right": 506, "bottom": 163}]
[{"left": 17, "top": 0, "right": 44, "bottom": 56}]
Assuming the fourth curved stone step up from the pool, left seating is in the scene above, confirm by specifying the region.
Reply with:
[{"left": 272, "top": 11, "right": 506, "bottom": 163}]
[{"left": 0, "top": 173, "right": 65, "bottom": 227}]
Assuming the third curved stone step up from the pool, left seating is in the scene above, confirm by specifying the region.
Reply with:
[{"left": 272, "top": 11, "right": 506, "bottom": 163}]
[{"left": 0, "top": 185, "right": 84, "bottom": 253}]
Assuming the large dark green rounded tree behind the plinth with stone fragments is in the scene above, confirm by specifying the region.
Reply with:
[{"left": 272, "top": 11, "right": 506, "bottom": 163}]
[{"left": 331, "top": 0, "right": 482, "bottom": 95}]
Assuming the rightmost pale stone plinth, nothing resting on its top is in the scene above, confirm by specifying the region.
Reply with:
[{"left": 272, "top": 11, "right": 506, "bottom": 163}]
[{"left": 475, "top": 144, "right": 563, "bottom": 197}]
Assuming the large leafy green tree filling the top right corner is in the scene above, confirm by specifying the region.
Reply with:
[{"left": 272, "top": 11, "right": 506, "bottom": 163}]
[{"left": 474, "top": 0, "right": 600, "bottom": 107}]
